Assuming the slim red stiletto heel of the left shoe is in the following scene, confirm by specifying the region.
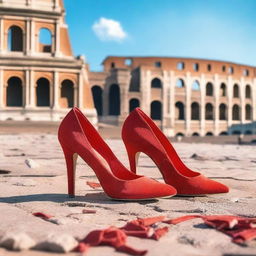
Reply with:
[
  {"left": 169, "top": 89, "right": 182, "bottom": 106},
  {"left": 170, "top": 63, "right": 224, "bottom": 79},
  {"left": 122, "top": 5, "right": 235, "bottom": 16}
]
[{"left": 62, "top": 147, "right": 78, "bottom": 197}]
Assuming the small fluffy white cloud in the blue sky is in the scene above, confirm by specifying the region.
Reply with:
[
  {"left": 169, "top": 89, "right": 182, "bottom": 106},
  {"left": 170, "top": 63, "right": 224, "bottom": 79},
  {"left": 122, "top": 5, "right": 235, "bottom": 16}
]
[{"left": 92, "top": 17, "right": 127, "bottom": 42}]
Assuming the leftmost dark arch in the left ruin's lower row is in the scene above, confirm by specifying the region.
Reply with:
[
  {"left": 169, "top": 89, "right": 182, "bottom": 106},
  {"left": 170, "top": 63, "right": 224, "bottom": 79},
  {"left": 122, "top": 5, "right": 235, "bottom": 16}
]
[{"left": 6, "top": 77, "right": 23, "bottom": 107}]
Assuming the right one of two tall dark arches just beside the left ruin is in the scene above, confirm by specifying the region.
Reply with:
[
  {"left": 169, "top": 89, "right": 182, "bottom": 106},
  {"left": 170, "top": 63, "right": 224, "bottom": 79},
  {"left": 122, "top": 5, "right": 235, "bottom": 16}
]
[{"left": 108, "top": 84, "right": 120, "bottom": 116}]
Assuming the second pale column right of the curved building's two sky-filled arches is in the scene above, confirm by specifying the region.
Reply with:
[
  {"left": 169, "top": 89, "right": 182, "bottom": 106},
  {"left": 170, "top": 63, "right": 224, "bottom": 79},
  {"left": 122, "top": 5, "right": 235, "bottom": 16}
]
[{"left": 214, "top": 74, "right": 220, "bottom": 136}]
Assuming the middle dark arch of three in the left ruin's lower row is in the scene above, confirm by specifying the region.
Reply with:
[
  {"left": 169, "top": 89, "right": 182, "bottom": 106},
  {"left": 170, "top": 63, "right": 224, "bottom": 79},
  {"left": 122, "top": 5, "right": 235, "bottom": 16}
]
[{"left": 36, "top": 78, "right": 50, "bottom": 107}]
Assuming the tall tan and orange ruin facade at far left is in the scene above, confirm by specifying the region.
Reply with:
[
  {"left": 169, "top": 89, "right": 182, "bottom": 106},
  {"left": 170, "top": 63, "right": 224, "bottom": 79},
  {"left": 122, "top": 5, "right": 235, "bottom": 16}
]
[{"left": 0, "top": 0, "right": 97, "bottom": 122}]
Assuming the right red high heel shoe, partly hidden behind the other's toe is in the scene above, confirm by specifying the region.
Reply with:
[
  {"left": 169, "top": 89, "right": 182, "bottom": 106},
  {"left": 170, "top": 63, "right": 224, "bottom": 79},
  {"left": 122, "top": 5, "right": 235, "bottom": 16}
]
[{"left": 122, "top": 108, "right": 229, "bottom": 195}]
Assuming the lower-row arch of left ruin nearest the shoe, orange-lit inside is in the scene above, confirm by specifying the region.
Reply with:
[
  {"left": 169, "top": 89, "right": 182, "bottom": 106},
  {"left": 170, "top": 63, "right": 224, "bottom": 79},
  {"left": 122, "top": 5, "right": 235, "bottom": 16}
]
[{"left": 61, "top": 79, "right": 74, "bottom": 108}]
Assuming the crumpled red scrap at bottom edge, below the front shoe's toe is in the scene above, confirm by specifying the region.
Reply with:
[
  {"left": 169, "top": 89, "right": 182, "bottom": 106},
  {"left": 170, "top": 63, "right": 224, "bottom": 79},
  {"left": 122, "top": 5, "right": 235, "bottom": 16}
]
[{"left": 75, "top": 227, "right": 147, "bottom": 255}]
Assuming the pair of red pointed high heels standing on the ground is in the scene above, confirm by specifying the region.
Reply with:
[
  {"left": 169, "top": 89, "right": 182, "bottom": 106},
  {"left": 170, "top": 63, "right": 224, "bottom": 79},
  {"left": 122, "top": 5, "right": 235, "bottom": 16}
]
[{"left": 58, "top": 108, "right": 229, "bottom": 200}]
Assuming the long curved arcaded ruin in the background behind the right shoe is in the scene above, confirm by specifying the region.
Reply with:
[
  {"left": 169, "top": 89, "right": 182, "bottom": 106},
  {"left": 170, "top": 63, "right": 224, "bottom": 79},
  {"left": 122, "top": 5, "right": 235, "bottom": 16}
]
[{"left": 89, "top": 57, "right": 256, "bottom": 136}]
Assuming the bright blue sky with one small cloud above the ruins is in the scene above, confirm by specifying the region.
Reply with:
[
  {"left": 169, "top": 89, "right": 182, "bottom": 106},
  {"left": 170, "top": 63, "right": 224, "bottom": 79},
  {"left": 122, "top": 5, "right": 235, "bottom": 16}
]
[{"left": 64, "top": 0, "right": 256, "bottom": 71}]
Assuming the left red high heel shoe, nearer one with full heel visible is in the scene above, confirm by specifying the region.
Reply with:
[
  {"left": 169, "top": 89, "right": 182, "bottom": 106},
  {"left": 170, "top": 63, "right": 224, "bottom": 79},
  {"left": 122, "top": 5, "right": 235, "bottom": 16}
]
[{"left": 58, "top": 108, "right": 176, "bottom": 200}]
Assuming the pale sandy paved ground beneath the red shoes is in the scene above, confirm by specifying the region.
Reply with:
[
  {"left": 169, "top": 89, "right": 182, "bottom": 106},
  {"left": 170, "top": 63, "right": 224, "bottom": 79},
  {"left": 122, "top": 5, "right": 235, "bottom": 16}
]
[{"left": 0, "top": 133, "right": 256, "bottom": 256}]
